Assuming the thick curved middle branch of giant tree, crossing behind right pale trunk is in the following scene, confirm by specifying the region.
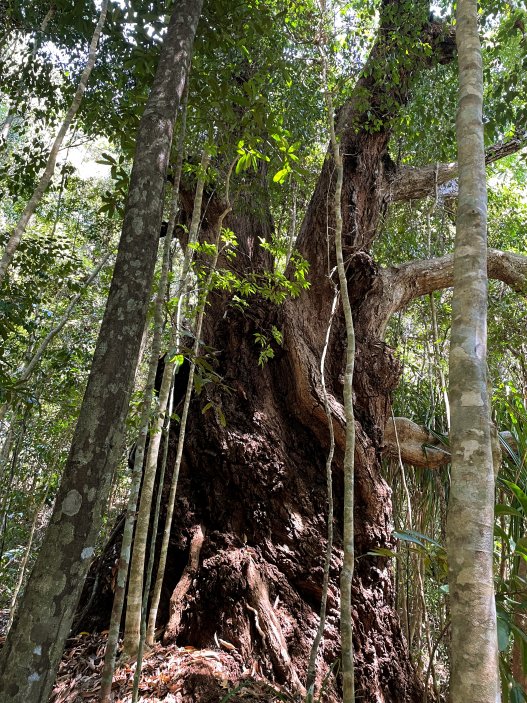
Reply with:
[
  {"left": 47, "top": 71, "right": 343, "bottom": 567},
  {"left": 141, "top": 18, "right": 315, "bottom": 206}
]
[{"left": 378, "top": 249, "right": 527, "bottom": 329}]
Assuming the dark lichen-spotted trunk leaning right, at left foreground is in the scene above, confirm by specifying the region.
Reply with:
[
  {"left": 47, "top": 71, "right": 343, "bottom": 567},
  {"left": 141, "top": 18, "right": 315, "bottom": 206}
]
[{"left": 0, "top": 0, "right": 202, "bottom": 703}]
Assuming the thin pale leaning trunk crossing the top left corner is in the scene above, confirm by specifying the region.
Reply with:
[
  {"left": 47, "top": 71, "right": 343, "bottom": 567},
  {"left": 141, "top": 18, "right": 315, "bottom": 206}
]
[{"left": 0, "top": 0, "right": 108, "bottom": 285}]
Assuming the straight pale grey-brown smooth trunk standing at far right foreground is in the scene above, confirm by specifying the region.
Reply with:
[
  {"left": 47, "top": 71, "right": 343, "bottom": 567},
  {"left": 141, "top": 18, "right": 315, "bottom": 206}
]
[{"left": 447, "top": 0, "right": 500, "bottom": 703}]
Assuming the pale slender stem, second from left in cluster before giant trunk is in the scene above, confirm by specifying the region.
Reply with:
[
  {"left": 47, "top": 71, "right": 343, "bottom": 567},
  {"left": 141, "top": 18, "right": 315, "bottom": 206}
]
[{"left": 123, "top": 144, "right": 210, "bottom": 656}]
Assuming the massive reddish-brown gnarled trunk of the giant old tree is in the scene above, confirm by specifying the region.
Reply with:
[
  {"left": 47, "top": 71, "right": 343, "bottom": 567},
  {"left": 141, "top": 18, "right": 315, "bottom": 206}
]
[{"left": 73, "top": 0, "right": 458, "bottom": 703}]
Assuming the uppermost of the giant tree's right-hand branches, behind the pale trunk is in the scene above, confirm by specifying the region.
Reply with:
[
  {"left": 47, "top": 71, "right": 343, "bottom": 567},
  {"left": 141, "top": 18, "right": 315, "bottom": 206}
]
[{"left": 385, "top": 133, "right": 527, "bottom": 202}]
